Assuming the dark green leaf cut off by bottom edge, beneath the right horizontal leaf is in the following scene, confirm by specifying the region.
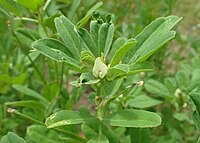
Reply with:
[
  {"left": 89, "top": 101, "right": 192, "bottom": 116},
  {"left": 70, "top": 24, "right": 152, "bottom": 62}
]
[{"left": 130, "top": 128, "right": 151, "bottom": 143}]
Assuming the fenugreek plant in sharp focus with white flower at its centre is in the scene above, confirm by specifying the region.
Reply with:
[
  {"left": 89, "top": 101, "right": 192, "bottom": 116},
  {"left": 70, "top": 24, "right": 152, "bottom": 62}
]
[{"left": 32, "top": 5, "right": 181, "bottom": 143}]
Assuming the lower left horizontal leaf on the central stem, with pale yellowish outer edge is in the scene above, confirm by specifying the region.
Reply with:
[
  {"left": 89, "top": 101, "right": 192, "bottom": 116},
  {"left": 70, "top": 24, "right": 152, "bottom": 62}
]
[{"left": 45, "top": 110, "right": 96, "bottom": 128}]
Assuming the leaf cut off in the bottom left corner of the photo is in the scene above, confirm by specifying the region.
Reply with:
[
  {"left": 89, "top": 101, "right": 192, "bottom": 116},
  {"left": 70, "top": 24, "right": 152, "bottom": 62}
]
[{"left": 0, "top": 132, "right": 26, "bottom": 143}]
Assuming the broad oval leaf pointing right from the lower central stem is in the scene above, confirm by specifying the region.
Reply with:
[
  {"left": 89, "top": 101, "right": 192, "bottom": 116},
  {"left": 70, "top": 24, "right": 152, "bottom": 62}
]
[{"left": 103, "top": 109, "right": 161, "bottom": 128}]
